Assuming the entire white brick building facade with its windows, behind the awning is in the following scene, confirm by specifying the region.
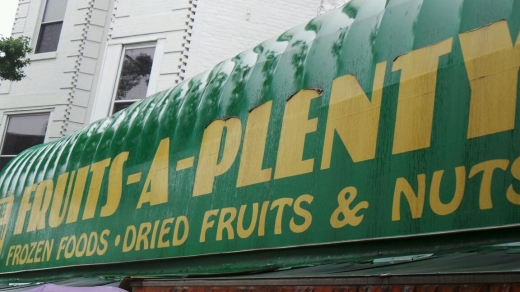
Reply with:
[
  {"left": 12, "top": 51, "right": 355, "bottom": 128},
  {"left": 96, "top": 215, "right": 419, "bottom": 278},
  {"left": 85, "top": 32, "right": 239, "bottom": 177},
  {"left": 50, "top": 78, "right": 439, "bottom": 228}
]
[{"left": 0, "top": 0, "right": 345, "bottom": 168}]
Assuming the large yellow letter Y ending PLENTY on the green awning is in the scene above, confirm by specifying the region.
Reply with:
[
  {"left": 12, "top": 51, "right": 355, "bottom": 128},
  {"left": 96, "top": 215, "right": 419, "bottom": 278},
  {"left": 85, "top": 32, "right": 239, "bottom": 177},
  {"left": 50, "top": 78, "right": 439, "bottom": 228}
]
[{"left": 459, "top": 20, "right": 520, "bottom": 139}]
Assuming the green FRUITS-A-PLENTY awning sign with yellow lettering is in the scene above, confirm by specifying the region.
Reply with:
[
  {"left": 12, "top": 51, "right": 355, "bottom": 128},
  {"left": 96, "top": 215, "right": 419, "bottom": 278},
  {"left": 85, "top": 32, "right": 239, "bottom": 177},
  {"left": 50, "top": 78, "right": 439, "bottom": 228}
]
[{"left": 0, "top": 0, "right": 520, "bottom": 272}]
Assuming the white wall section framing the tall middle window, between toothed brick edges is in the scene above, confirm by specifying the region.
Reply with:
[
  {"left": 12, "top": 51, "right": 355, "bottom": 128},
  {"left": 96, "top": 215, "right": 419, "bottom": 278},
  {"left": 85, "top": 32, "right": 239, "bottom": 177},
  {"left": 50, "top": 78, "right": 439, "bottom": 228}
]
[{"left": 89, "top": 0, "right": 194, "bottom": 122}]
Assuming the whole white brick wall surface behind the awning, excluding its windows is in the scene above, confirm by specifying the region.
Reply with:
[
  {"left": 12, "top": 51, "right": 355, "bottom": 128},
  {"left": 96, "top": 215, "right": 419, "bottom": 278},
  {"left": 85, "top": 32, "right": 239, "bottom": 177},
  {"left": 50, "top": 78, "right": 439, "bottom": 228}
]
[{"left": 0, "top": 0, "right": 340, "bottom": 141}]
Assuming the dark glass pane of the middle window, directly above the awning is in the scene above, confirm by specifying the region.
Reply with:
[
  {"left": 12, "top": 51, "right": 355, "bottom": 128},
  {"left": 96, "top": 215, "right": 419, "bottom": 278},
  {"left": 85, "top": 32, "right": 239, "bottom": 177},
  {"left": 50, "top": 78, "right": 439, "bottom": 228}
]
[{"left": 114, "top": 47, "right": 155, "bottom": 101}]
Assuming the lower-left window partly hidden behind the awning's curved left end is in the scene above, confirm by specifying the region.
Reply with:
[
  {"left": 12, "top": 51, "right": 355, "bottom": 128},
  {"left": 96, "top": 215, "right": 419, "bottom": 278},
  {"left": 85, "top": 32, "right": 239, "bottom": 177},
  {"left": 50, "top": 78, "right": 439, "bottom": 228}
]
[{"left": 0, "top": 113, "right": 49, "bottom": 170}]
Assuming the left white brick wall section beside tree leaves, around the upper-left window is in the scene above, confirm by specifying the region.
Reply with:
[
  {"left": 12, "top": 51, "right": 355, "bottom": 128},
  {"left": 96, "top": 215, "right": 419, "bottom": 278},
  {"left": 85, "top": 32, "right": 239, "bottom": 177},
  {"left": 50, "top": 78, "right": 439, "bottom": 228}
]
[{"left": 0, "top": 0, "right": 114, "bottom": 143}]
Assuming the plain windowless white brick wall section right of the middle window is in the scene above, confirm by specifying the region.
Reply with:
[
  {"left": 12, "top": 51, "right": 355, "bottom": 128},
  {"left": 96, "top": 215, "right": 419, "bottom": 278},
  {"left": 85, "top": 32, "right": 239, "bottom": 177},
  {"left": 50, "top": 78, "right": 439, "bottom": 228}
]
[{"left": 184, "top": 0, "right": 321, "bottom": 78}]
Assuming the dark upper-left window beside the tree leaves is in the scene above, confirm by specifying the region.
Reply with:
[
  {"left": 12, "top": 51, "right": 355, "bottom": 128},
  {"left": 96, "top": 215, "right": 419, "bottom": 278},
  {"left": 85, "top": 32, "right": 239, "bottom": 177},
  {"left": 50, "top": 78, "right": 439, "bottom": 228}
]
[{"left": 36, "top": 0, "right": 67, "bottom": 54}]
